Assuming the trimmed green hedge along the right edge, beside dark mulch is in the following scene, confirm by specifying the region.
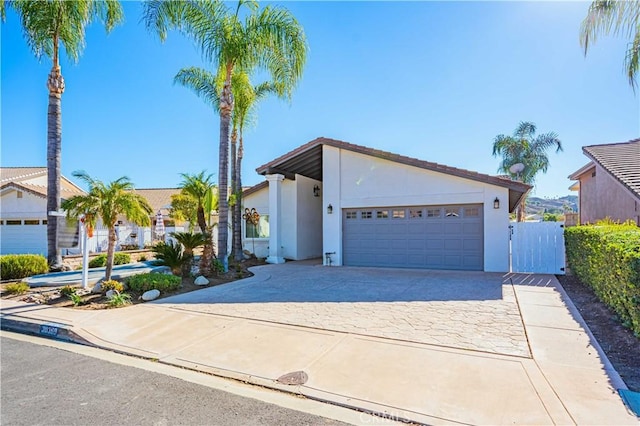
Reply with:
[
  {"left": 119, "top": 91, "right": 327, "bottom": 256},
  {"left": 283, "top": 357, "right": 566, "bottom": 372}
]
[{"left": 565, "top": 224, "right": 640, "bottom": 337}]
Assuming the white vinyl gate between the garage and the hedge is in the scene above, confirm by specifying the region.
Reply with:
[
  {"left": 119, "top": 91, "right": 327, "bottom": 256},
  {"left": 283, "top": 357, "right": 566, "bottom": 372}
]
[{"left": 509, "top": 222, "right": 565, "bottom": 275}]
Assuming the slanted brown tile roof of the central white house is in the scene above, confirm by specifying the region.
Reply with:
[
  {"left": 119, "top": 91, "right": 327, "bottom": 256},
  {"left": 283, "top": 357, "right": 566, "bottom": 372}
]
[{"left": 256, "top": 137, "right": 531, "bottom": 211}]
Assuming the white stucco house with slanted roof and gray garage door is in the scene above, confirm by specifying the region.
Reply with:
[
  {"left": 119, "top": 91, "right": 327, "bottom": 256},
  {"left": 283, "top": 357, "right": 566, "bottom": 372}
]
[{"left": 243, "top": 138, "right": 531, "bottom": 272}]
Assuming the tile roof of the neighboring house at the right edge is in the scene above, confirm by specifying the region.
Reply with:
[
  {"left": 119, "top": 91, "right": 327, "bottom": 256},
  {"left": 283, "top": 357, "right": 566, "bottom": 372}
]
[{"left": 582, "top": 139, "right": 640, "bottom": 198}]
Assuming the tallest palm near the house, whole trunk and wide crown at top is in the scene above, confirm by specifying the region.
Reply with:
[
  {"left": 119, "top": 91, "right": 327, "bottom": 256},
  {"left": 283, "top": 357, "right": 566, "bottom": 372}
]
[{"left": 143, "top": 0, "right": 307, "bottom": 271}]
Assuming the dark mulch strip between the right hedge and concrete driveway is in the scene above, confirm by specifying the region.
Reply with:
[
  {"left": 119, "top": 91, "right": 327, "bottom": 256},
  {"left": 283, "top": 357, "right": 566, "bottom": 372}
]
[{"left": 557, "top": 275, "right": 640, "bottom": 392}]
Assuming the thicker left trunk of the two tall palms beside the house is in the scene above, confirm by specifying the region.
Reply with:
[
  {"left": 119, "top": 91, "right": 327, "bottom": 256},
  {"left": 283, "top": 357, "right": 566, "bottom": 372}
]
[{"left": 218, "top": 64, "right": 233, "bottom": 272}]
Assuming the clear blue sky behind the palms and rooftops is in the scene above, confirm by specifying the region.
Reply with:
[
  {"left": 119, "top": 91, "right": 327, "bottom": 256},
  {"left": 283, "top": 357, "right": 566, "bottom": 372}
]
[{"left": 0, "top": 2, "right": 640, "bottom": 196}]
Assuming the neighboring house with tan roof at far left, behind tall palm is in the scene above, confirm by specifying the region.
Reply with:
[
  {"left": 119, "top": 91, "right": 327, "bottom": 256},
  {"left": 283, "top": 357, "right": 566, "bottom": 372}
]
[{"left": 0, "top": 167, "right": 84, "bottom": 256}]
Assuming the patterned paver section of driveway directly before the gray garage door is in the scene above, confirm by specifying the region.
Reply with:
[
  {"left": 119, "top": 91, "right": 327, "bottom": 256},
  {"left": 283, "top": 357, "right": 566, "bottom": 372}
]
[{"left": 157, "top": 262, "right": 531, "bottom": 357}]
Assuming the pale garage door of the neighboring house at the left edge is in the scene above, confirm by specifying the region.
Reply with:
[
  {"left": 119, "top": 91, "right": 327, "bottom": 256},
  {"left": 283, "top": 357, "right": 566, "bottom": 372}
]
[{"left": 0, "top": 219, "right": 47, "bottom": 255}]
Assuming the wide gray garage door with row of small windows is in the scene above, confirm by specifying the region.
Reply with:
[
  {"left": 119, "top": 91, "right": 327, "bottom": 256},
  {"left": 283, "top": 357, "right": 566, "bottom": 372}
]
[{"left": 342, "top": 204, "right": 483, "bottom": 271}]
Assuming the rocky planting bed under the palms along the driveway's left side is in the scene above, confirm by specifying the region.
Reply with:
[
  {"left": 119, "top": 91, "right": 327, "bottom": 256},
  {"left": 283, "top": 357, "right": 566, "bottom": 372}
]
[{"left": 0, "top": 259, "right": 264, "bottom": 310}]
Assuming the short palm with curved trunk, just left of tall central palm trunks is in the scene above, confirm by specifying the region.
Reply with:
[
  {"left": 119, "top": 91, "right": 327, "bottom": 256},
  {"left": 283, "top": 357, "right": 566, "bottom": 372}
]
[{"left": 180, "top": 170, "right": 220, "bottom": 275}]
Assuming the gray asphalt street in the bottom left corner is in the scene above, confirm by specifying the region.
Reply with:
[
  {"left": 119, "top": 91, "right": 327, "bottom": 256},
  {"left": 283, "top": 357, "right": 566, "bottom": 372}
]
[{"left": 0, "top": 336, "right": 350, "bottom": 426}]
